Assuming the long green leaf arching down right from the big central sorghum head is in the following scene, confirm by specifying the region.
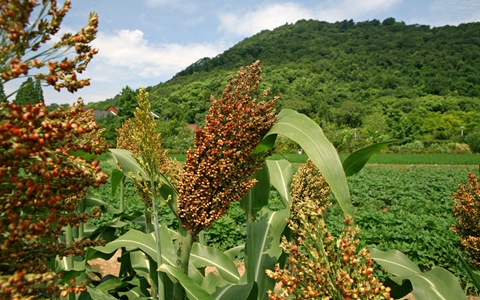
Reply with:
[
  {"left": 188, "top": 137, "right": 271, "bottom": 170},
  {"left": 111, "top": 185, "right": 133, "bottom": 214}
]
[{"left": 267, "top": 109, "right": 353, "bottom": 215}]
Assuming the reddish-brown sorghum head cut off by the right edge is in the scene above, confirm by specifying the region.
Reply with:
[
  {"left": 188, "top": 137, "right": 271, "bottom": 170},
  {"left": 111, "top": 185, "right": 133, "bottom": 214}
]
[{"left": 452, "top": 173, "right": 480, "bottom": 268}]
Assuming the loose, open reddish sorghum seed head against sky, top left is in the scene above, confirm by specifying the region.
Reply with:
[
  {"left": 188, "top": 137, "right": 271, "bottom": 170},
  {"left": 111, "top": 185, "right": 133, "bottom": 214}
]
[{"left": 0, "top": 0, "right": 98, "bottom": 92}]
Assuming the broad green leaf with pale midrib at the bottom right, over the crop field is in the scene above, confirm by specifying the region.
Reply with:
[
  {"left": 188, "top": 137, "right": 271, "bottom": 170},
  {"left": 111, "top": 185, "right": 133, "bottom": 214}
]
[{"left": 370, "top": 249, "right": 467, "bottom": 300}]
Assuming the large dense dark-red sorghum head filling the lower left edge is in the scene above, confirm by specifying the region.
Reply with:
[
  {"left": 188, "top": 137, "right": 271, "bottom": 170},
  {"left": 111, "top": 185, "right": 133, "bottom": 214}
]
[{"left": 0, "top": 104, "right": 107, "bottom": 298}]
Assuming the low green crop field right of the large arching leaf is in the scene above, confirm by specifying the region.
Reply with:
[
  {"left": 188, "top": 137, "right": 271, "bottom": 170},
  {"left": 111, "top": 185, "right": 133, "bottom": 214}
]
[{"left": 327, "top": 166, "right": 478, "bottom": 292}]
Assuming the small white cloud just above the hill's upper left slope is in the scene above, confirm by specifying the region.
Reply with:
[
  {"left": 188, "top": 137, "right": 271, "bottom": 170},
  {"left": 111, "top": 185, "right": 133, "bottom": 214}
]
[{"left": 219, "top": 2, "right": 313, "bottom": 36}]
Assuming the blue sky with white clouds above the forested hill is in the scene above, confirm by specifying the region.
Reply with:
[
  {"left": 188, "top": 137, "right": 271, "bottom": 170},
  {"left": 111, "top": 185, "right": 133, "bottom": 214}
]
[{"left": 5, "top": 0, "right": 480, "bottom": 104}]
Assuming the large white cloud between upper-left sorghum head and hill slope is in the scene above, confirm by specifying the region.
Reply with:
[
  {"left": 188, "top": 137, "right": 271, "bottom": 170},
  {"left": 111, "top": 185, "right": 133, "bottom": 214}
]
[{"left": 5, "top": 30, "right": 231, "bottom": 104}]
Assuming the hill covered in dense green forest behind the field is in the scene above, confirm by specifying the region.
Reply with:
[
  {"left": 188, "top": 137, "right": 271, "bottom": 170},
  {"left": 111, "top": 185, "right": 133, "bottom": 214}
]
[{"left": 90, "top": 18, "right": 480, "bottom": 152}]
